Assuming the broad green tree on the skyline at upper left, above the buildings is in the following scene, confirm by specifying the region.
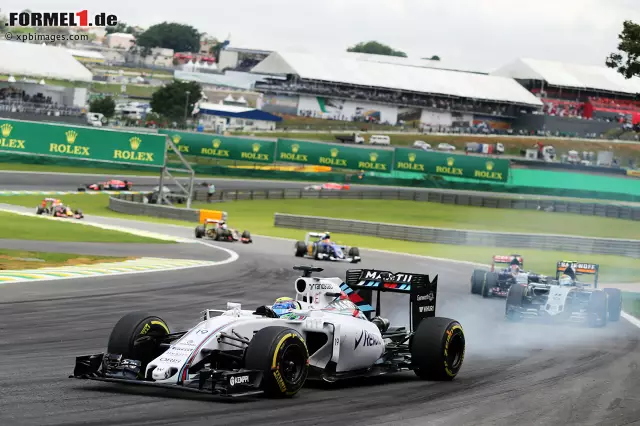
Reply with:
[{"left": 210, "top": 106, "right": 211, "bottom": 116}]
[{"left": 137, "top": 22, "right": 200, "bottom": 52}]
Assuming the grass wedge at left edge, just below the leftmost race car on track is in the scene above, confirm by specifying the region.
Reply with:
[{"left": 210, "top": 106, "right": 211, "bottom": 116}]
[{"left": 0, "top": 210, "right": 171, "bottom": 244}]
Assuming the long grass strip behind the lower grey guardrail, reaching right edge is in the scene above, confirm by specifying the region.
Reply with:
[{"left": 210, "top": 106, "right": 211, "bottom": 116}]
[{"left": 193, "top": 199, "right": 640, "bottom": 240}]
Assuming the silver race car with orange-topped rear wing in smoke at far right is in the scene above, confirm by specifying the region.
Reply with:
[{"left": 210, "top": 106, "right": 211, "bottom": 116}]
[{"left": 505, "top": 260, "right": 622, "bottom": 327}]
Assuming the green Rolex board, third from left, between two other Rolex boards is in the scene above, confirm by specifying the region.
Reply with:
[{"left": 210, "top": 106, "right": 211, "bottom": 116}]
[{"left": 276, "top": 139, "right": 393, "bottom": 173}]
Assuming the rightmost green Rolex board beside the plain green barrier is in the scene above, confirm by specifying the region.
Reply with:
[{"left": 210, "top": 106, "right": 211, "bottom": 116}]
[{"left": 394, "top": 148, "right": 509, "bottom": 182}]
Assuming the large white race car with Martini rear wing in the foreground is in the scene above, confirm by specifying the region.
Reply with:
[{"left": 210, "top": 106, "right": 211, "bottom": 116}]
[{"left": 71, "top": 266, "right": 465, "bottom": 397}]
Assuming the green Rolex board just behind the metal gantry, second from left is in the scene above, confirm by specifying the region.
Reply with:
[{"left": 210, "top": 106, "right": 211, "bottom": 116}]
[{"left": 159, "top": 129, "right": 276, "bottom": 163}]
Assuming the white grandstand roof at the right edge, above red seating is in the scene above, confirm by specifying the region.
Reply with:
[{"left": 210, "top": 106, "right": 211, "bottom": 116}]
[{"left": 491, "top": 58, "right": 640, "bottom": 94}]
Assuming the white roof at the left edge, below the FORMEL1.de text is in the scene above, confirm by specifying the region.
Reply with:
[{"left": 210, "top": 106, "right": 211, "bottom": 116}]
[{"left": 0, "top": 40, "right": 93, "bottom": 82}]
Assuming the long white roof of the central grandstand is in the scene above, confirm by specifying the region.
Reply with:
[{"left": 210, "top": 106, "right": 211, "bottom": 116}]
[{"left": 252, "top": 52, "right": 542, "bottom": 106}]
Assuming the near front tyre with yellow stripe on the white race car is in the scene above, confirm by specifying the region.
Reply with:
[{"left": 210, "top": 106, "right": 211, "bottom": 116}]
[{"left": 244, "top": 326, "right": 309, "bottom": 398}]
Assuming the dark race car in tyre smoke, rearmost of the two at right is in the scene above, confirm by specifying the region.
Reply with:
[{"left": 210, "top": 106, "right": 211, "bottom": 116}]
[{"left": 471, "top": 254, "right": 548, "bottom": 298}]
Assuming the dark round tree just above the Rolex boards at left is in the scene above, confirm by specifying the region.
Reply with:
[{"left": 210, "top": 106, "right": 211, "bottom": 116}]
[{"left": 151, "top": 80, "right": 202, "bottom": 122}]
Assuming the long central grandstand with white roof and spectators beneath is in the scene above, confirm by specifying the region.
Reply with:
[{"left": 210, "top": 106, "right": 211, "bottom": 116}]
[{"left": 252, "top": 52, "right": 543, "bottom": 127}]
